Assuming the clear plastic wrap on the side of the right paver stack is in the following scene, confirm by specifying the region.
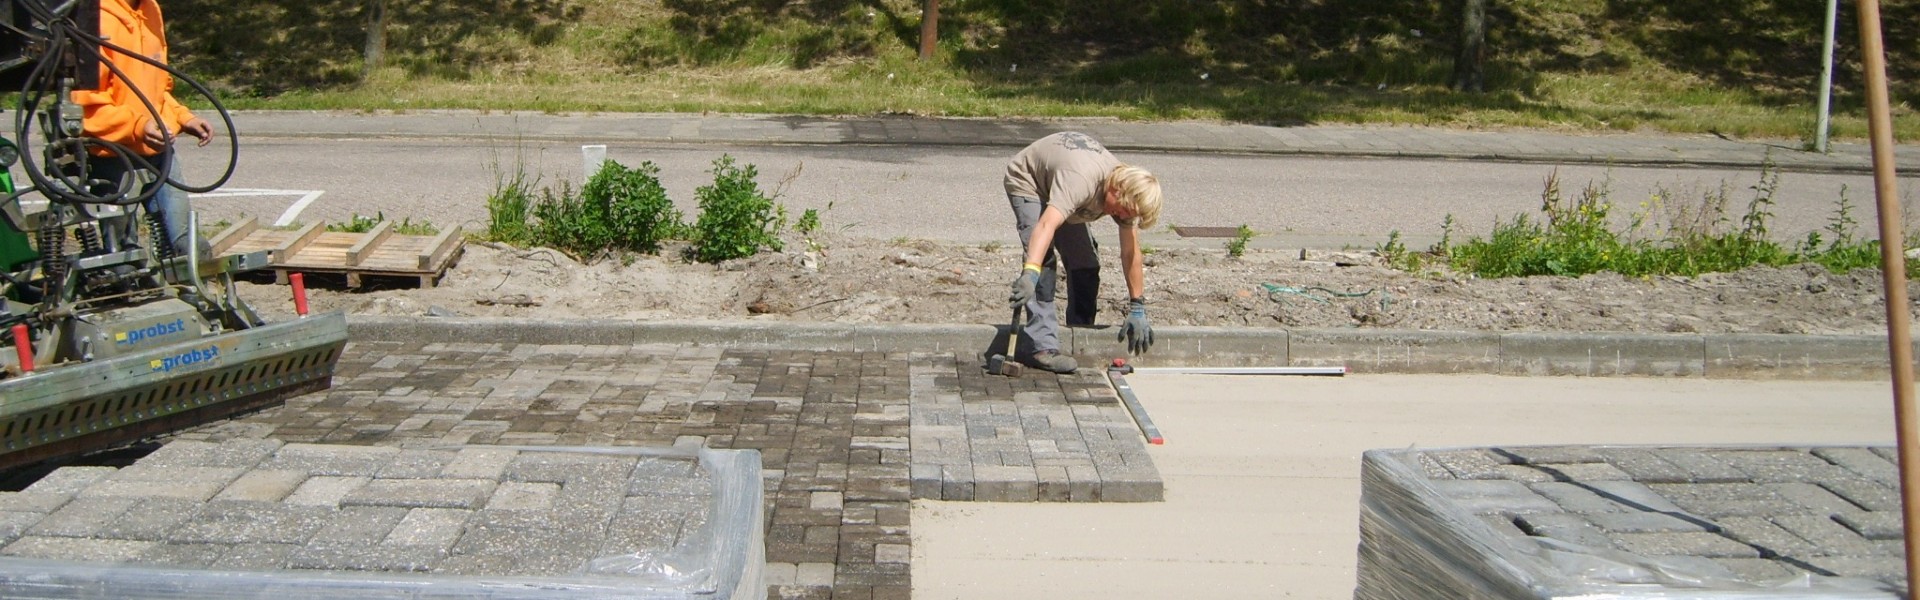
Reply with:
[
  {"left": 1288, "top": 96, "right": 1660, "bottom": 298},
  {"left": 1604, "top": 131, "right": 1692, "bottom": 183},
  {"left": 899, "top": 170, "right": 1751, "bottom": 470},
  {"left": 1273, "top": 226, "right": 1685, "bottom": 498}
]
[{"left": 1354, "top": 450, "right": 1905, "bottom": 600}]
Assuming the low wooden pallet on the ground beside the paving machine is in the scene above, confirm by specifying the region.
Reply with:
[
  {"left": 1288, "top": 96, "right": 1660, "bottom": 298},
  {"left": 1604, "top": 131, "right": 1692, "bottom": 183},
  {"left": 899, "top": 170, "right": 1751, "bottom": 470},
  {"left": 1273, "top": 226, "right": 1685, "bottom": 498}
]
[{"left": 211, "top": 217, "right": 467, "bottom": 288}]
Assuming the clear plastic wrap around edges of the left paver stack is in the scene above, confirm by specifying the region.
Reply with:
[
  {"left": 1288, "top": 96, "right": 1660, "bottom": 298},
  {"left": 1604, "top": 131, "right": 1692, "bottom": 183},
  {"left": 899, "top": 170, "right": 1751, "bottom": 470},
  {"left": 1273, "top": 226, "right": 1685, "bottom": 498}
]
[{"left": 0, "top": 446, "right": 766, "bottom": 600}]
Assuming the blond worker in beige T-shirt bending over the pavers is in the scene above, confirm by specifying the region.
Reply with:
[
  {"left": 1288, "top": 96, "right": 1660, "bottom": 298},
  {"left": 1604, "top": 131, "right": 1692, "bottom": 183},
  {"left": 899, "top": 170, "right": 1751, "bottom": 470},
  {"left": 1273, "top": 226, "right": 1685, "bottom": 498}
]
[{"left": 1006, "top": 131, "right": 1160, "bottom": 373}]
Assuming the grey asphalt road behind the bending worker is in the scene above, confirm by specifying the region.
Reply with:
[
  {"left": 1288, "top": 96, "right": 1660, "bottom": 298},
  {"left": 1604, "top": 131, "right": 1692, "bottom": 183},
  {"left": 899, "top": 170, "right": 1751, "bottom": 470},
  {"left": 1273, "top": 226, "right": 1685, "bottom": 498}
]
[{"left": 172, "top": 138, "right": 1920, "bottom": 248}]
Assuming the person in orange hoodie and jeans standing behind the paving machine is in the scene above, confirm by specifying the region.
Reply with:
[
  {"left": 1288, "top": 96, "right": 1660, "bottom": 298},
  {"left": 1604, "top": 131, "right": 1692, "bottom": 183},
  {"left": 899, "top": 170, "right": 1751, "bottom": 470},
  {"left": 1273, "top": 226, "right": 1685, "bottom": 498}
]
[{"left": 73, "top": 0, "right": 213, "bottom": 254}]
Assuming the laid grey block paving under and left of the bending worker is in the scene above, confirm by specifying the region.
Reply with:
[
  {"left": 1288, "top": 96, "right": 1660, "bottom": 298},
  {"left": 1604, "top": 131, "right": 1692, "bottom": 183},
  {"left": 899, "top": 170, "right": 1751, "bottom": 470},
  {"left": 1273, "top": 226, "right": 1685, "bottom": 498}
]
[{"left": 145, "top": 342, "right": 1162, "bottom": 598}]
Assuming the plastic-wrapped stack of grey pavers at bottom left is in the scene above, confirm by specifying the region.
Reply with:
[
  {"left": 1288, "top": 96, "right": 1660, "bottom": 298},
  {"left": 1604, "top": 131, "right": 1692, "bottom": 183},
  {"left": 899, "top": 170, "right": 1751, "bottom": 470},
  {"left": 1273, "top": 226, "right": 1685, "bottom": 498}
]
[{"left": 0, "top": 440, "right": 766, "bottom": 600}]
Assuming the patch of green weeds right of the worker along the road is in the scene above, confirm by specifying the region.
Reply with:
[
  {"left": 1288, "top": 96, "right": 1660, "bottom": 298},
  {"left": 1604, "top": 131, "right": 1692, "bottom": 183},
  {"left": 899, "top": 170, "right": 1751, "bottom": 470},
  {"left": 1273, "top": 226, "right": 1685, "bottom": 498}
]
[{"left": 1436, "top": 163, "right": 1916, "bottom": 277}]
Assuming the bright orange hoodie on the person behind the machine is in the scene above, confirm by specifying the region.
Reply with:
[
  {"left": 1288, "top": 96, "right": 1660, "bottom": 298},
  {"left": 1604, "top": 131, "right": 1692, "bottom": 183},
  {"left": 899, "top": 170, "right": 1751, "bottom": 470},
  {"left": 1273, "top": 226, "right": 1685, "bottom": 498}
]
[{"left": 73, "top": 0, "right": 194, "bottom": 156}]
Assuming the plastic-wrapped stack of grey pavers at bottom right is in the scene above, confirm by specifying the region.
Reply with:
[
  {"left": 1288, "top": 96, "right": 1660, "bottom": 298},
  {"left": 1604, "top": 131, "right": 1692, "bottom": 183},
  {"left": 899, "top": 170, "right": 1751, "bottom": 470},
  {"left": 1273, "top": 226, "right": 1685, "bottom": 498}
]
[{"left": 1354, "top": 446, "right": 1905, "bottom": 600}]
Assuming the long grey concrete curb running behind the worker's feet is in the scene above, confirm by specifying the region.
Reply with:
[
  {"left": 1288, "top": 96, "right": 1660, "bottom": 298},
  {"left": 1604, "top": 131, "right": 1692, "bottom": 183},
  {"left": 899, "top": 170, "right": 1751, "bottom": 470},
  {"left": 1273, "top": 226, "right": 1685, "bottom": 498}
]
[{"left": 348, "top": 315, "right": 1920, "bottom": 379}]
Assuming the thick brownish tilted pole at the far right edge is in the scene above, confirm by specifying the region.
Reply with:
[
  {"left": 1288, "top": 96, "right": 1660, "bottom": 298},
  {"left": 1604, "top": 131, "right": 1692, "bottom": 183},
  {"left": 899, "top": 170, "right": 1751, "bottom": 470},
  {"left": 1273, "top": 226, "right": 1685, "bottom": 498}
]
[{"left": 1860, "top": 0, "right": 1920, "bottom": 600}]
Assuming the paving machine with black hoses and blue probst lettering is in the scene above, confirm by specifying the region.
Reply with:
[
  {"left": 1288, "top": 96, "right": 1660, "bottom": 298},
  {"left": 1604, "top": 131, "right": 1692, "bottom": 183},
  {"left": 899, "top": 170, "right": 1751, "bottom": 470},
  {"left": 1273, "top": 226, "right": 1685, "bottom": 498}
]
[{"left": 0, "top": 0, "right": 348, "bottom": 469}]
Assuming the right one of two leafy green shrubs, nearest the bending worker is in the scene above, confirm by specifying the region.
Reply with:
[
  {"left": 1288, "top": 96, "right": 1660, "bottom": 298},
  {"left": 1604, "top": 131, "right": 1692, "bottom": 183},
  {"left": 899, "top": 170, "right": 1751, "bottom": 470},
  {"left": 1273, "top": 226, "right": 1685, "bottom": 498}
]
[{"left": 693, "top": 154, "right": 787, "bottom": 263}]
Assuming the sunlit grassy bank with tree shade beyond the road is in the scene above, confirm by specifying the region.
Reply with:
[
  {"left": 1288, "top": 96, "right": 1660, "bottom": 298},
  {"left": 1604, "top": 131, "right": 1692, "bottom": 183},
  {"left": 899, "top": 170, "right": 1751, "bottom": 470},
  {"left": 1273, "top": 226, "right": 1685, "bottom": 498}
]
[{"left": 169, "top": 0, "right": 1920, "bottom": 140}]
